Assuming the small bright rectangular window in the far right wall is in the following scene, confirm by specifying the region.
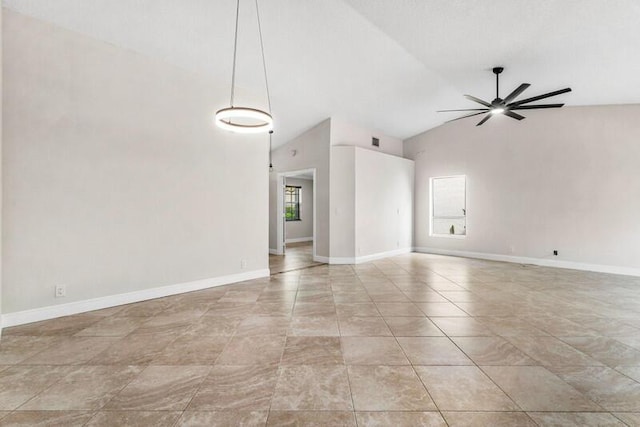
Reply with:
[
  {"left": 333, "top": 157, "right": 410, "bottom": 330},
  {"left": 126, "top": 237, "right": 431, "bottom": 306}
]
[{"left": 430, "top": 175, "right": 467, "bottom": 237}]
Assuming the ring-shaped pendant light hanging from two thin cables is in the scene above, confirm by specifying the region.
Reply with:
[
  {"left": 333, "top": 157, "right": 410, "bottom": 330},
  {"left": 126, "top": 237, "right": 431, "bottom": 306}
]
[{"left": 215, "top": 0, "right": 273, "bottom": 133}]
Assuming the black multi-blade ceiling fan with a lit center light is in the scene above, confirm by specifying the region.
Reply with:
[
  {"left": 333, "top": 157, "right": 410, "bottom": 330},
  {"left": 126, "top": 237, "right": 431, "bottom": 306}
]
[{"left": 438, "top": 67, "right": 571, "bottom": 126}]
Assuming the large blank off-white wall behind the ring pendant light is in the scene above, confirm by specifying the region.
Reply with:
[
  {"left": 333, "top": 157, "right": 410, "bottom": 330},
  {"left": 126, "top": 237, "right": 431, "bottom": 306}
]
[{"left": 2, "top": 10, "right": 268, "bottom": 320}]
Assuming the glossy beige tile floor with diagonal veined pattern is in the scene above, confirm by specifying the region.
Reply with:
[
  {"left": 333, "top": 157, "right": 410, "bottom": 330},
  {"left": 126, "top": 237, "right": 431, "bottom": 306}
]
[{"left": 0, "top": 254, "right": 640, "bottom": 426}]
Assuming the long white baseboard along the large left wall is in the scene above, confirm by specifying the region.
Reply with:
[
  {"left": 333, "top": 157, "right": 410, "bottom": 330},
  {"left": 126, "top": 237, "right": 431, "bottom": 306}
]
[{"left": 2, "top": 269, "right": 269, "bottom": 328}]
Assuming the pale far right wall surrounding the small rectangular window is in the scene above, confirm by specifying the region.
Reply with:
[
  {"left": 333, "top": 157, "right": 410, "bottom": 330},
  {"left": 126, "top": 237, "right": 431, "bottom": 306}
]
[{"left": 404, "top": 105, "right": 640, "bottom": 274}]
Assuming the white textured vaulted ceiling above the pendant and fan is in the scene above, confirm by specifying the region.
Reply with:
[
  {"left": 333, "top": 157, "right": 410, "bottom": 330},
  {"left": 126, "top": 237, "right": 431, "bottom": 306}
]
[{"left": 3, "top": 0, "right": 640, "bottom": 146}]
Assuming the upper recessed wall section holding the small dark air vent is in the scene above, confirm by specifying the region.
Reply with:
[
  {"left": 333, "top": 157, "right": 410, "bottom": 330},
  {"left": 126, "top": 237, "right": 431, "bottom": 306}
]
[{"left": 331, "top": 117, "right": 403, "bottom": 157}]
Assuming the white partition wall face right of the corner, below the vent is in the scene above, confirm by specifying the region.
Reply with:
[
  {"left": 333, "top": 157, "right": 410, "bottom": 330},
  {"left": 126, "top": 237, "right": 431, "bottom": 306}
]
[{"left": 354, "top": 148, "right": 414, "bottom": 258}]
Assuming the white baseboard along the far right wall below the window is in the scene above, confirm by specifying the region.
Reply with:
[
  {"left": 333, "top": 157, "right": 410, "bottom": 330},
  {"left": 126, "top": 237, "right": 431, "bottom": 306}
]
[{"left": 413, "top": 247, "right": 640, "bottom": 277}]
